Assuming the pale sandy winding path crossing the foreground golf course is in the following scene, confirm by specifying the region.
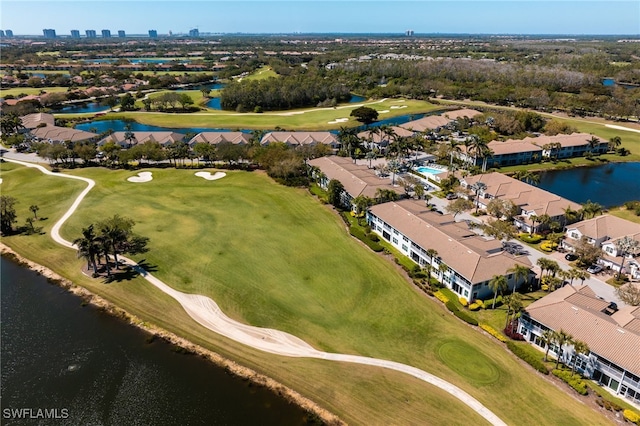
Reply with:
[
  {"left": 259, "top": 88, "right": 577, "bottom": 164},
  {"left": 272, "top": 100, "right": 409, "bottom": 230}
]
[{"left": 6, "top": 159, "right": 506, "bottom": 426}]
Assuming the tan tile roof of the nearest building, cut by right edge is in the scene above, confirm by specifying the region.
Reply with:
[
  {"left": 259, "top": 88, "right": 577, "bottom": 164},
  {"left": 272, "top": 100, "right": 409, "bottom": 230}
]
[{"left": 525, "top": 285, "right": 640, "bottom": 375}]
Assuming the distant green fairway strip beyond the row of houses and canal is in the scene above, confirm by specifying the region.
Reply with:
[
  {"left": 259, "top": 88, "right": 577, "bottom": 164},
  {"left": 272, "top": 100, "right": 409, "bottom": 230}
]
[{"left": 64, "top": 98, "right": 442, "bottom": 130}]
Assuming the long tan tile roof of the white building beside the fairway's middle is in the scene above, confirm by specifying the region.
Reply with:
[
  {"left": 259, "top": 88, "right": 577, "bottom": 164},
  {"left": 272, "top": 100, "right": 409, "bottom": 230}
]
[{"left": 370, "top": 200, "right": 531, "bottom": 283}]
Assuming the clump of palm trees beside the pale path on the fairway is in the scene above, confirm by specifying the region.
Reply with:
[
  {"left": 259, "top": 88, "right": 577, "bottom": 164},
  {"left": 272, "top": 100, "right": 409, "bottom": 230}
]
[{"left": 73, "top": 214, "right": 149, "bottom": 279}]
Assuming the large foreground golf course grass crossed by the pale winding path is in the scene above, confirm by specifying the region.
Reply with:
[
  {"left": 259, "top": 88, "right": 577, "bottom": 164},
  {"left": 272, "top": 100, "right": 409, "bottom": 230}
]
[{"left": 0, "top": 163, "right": 607, "bottom": 425}]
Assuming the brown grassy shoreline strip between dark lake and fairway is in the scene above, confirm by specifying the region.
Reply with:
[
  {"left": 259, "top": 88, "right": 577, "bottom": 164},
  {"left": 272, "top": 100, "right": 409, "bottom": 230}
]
[{"left": 0, "top": 242, "right": 346, "bottom": 426}]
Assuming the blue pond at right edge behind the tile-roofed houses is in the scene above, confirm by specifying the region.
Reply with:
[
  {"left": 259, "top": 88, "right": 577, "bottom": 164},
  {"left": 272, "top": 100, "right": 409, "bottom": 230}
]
[{"left": 538, "top": 162, "right": 640, "bottom": 207}]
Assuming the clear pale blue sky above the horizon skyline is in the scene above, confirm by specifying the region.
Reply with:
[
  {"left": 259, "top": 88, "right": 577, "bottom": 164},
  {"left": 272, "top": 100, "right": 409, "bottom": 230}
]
[{"left": 0, "top": 0, "right": 640, "bottom": 35}]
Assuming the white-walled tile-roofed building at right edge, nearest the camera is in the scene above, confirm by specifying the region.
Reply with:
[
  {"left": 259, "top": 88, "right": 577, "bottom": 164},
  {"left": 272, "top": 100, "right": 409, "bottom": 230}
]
[{"left": 518, "top": 285, "right": 640, "bottom": 404}]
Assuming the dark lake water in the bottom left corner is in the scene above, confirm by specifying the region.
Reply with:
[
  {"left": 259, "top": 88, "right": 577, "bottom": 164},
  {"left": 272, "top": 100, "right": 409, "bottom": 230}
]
[{"left": 0, "top": 258, "right": 306, "bottom": 425}]
